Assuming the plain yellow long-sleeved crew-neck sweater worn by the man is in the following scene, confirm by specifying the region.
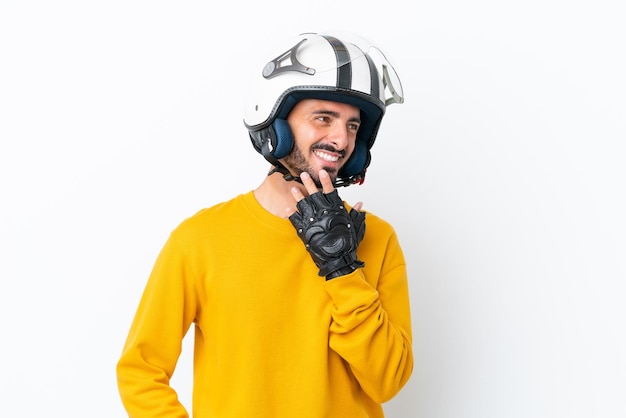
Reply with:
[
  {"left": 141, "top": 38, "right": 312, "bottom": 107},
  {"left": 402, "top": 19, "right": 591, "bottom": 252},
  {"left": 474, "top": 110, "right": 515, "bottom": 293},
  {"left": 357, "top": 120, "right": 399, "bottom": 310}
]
[{"left": 117, "top": 192, "right": 413, "bottom": 418}]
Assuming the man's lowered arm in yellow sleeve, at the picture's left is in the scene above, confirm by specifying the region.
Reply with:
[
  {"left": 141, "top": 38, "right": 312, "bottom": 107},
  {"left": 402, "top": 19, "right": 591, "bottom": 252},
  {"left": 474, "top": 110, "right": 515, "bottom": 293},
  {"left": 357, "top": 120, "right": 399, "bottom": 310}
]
[{"left": 117, "top": 233, "right": 195, "bottom": 418}]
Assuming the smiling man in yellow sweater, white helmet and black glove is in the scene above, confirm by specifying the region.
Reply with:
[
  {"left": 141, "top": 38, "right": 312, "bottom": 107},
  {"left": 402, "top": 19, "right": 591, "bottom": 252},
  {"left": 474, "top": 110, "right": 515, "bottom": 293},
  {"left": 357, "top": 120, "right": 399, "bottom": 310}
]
[{"left": 117, "top": 33, "right": 413, "bottom": 418}]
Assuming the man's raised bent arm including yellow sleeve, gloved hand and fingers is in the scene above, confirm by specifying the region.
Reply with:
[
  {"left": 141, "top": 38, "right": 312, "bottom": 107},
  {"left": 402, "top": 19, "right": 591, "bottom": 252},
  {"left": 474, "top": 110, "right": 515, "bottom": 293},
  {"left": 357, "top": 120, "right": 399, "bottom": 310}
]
[{"left": 290, "top": 170, "right": 413, "bottom": 403}]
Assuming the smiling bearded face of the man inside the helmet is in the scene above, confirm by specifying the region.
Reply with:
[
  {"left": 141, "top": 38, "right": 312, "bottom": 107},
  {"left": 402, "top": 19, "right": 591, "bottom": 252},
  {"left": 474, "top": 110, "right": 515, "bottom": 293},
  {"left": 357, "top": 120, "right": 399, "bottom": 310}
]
[{"left": 281, "top": 99, "right": 361, "bottom": 187}]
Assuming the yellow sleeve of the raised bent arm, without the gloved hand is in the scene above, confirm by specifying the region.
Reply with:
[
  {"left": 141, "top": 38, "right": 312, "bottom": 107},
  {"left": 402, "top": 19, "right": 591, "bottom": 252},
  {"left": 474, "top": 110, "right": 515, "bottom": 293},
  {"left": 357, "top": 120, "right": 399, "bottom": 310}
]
[{"left": 326, "top": 231, "right": 413, "bottom": 403}]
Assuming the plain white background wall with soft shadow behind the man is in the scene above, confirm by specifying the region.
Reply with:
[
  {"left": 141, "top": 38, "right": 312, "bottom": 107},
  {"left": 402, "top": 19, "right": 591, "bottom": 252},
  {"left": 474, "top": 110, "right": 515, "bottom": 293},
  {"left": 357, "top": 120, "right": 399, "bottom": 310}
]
[{"left": 0, "top": 0, "right": 626, "bottom": 418}]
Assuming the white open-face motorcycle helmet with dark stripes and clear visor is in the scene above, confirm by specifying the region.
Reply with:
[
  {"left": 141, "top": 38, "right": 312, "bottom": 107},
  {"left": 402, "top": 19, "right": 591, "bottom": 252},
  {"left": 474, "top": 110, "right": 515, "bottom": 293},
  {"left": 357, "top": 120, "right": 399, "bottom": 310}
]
[{"left": 244, "top": 33, "right": 404, "bottom": 186}]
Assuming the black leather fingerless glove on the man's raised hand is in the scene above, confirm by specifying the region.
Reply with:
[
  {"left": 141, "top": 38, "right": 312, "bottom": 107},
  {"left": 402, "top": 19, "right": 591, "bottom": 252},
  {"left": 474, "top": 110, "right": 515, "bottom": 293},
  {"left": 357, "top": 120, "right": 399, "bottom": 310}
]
[{"left": 289, "top": 190, "right": 365, "bottom": 280}]
